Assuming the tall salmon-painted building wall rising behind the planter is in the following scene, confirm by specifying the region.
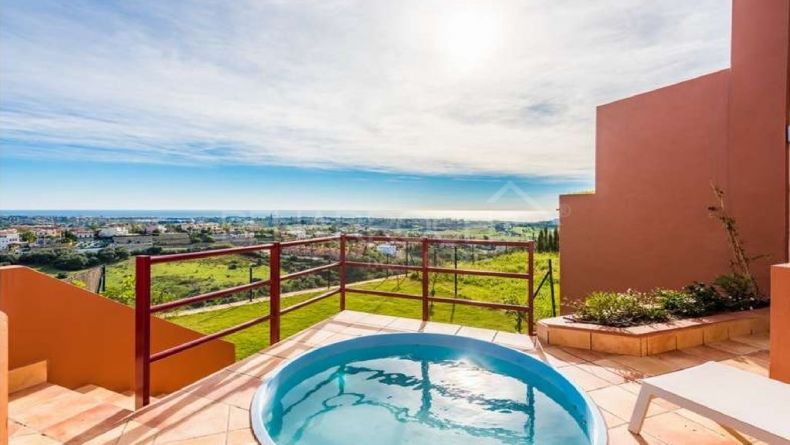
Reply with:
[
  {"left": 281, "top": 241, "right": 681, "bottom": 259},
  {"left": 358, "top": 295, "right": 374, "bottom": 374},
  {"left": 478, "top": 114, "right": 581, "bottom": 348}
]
[{"left": 560, "top": 0, "right": 790, "bottom": 313}]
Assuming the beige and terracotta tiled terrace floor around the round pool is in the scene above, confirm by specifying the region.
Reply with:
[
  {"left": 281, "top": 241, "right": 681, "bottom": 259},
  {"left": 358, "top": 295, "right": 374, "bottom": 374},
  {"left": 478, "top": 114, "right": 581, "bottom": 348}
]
[{"left": 16, "top": 311, "right": 768, "bottom": 445}]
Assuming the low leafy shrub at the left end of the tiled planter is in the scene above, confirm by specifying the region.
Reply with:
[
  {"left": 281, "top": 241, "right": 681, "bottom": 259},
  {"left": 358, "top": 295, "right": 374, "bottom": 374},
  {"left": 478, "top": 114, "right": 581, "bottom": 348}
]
[{"left": 575, "top": 290, "right": 669, "bottom": 327}]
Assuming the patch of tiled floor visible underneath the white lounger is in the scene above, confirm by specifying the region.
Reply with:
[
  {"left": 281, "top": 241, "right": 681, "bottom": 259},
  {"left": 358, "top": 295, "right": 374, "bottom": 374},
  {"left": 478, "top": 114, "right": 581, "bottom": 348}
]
[{"left": 643, "top": 412, "right": 741, "bottom": 445}]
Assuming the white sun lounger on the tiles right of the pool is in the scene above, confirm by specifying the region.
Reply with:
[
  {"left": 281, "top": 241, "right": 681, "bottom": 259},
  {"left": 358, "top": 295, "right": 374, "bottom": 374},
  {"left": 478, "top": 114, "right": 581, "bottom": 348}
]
[{"left": 628, "top": 362, "right": 790, "bottom": 445}]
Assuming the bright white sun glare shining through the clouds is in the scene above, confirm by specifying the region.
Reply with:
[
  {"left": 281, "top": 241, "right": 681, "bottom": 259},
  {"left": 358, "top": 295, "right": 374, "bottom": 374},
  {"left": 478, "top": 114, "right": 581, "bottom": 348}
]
[{"left": 437, "top": 10, "right": 500, "bottom": 70}]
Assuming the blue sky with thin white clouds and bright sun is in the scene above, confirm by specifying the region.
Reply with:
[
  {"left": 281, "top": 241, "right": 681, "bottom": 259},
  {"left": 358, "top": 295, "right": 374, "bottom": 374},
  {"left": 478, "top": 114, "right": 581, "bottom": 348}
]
[{"left": 0, "top": 0, "right": 731, "bottom": 219}]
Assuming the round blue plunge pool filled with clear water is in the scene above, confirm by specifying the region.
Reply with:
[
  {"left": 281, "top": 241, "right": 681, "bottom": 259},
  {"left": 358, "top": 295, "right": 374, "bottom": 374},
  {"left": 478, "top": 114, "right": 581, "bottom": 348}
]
[{"left": 252, "top": 334, "right": 606, "bottom": 445}]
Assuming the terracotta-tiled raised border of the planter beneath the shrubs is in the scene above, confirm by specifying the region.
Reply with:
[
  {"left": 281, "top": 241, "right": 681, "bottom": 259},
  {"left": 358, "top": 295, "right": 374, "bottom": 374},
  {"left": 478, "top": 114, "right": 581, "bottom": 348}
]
[{"left": 538, "top": 308, "right": 769, "bottom": 356}]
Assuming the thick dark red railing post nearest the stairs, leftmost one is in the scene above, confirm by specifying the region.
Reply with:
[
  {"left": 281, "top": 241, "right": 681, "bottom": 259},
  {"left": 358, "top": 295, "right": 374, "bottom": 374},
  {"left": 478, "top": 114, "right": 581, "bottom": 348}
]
[{"left": 134, "top": 255, "right": 151, "bottom": 409}]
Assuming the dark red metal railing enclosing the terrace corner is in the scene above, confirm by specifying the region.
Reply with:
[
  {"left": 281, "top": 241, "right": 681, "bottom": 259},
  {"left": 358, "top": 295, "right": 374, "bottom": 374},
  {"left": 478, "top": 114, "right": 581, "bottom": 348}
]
[{"left": 135, "top": 235, "right": 535, "bottom": 409}]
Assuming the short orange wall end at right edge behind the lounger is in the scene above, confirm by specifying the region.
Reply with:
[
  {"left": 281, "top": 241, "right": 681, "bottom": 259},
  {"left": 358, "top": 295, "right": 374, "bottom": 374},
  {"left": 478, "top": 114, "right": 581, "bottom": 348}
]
[{"left": 770, "top": 264, "right": 790, "bottom": 383}]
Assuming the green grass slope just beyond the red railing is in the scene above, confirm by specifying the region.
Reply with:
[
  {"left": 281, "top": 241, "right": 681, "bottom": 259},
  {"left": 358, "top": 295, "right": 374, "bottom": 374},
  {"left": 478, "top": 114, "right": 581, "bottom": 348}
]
[{"left": 170, "top": 253, "right": 559, "bottom": 359}]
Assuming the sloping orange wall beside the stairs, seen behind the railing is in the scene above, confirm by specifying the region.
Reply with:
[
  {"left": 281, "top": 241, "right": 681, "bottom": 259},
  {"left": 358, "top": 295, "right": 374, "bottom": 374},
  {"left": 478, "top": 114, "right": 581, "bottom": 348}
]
[{"left": 0, "top": 266, "right": 235, "bottom": 394}]
